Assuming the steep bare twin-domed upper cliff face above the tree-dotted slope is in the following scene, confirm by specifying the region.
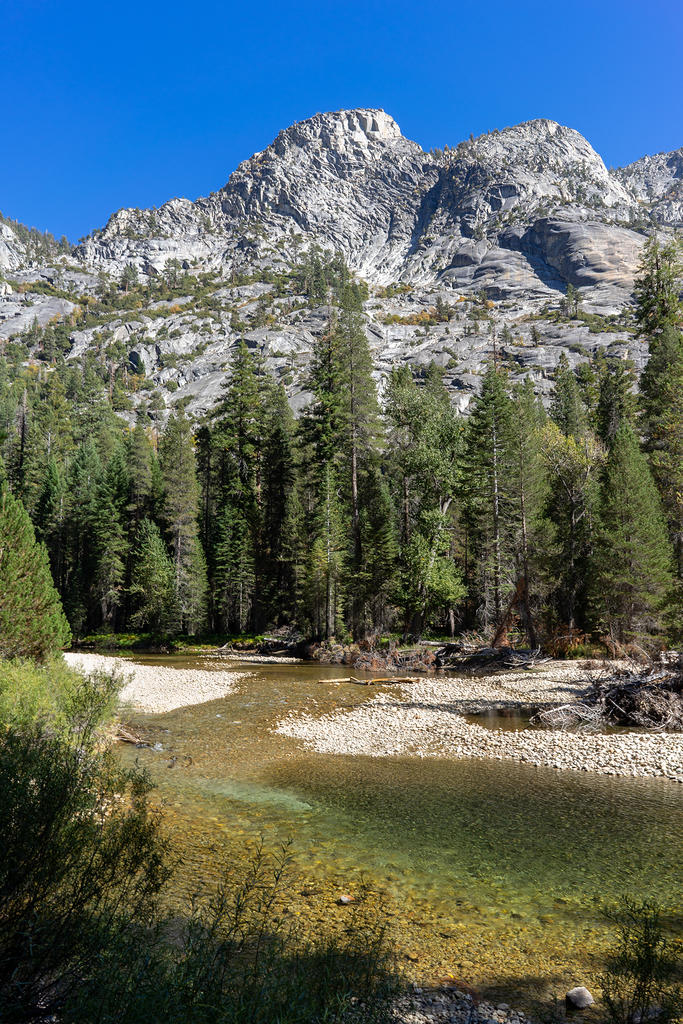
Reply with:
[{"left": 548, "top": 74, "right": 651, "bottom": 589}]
[{"left": 74, "top": 110, "right": 655, "bottom": 304}]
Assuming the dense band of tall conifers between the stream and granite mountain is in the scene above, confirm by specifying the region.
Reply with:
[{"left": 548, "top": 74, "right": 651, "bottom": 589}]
[{"left": 0, "top": 237, "right": 683, "bottom": 653}]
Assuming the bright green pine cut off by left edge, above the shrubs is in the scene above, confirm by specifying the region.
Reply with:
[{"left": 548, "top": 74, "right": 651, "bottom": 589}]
[{"left": 0, "top": 480, "right": 71, "bottom": 660}]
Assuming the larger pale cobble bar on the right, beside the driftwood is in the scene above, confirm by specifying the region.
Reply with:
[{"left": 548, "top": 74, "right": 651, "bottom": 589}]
[{"left": 276, "top": 663, "right": 683, "bottom": 782}]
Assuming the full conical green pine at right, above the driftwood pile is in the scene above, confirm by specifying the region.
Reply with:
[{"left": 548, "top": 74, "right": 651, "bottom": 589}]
[{"left": 591, "top": 423, "right": 673, "bottom": 642}]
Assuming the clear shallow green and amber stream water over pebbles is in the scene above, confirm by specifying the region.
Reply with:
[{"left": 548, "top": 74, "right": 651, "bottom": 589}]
[{"left": 117, "top": 658, "right": 683, "bottom": 995}]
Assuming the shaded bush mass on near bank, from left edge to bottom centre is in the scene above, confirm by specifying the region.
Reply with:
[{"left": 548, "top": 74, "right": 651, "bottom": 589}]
[{"left": 0, "top": 679, "right": 395, "bottom": 1024}]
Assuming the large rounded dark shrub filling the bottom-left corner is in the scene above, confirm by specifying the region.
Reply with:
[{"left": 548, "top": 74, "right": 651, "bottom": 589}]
[{"left": 0, "top": 684, "right": 168, "bottom": 1022}]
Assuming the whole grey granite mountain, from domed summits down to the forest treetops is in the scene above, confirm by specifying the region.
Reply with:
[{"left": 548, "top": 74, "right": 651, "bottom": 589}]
[{"left": 0, "top": 110, "right": 683, "bottom": 412}]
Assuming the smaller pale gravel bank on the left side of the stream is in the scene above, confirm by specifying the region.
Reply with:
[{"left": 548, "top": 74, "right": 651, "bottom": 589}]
[{"left": 65, "top": 653, "right": 248, "bottom": 715}]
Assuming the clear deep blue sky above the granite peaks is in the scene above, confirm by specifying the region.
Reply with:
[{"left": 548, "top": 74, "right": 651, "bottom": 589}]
[{"left": 0, "top": 0, "right": 683, "bottom": 240}]
